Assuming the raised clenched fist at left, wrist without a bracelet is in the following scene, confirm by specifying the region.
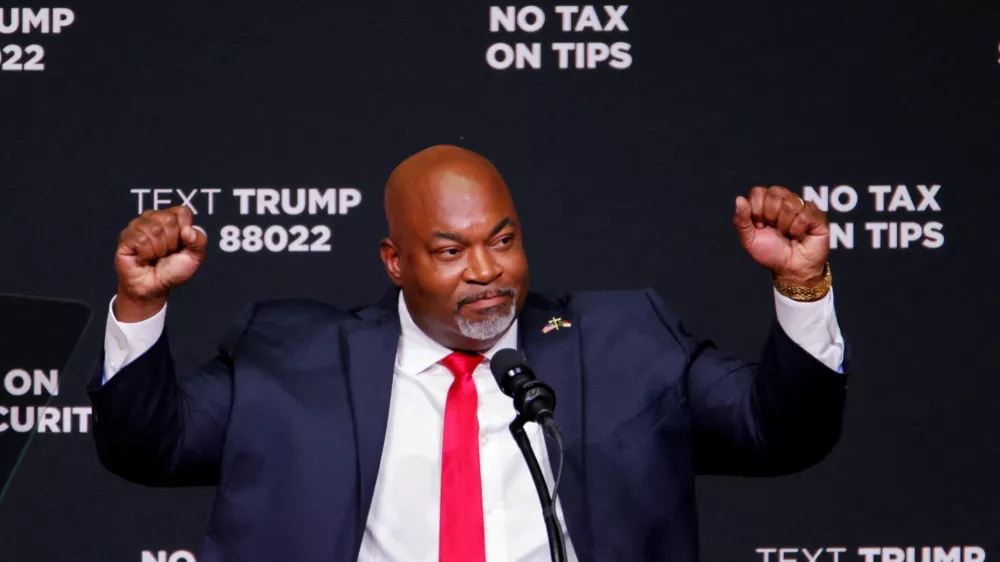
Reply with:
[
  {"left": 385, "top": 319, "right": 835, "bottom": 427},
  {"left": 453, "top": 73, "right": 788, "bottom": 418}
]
[{"left": 114, "top": 205, "right": 208, "bottom": 322}]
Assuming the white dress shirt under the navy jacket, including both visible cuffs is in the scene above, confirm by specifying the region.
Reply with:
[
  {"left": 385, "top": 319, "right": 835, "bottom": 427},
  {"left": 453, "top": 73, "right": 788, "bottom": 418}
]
[{"left": 104, "top": 291, "right": 844, "bottom": 562}]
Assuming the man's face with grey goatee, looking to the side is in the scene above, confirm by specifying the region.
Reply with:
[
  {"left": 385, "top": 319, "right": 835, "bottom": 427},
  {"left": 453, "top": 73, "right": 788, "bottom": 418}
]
[{"left": 383, "top": 166, "right": 528, "bottom": 350}]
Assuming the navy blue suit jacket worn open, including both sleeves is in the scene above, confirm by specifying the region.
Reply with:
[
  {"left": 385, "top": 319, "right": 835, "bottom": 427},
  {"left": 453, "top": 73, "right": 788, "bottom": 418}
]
[{"left": 89, "top": 290, "right": 846, "bottom": 562}]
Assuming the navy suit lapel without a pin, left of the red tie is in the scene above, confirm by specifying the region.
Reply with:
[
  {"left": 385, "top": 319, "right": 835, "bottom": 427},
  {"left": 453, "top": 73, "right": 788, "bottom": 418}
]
[{"left": 346, "top": 290, "right": 400, "bottom": 540}]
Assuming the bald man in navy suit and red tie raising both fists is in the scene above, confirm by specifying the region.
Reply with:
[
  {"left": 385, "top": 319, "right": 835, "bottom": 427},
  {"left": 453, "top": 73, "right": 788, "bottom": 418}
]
[{"left": 90, "top": 146, "right": 845, "bottom": 562}]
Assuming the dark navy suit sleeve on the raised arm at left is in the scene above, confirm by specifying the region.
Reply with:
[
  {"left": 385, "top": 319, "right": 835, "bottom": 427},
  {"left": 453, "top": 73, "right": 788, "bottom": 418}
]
[{"left": 87, "top": 306, "right": 256, "bottom": 486}]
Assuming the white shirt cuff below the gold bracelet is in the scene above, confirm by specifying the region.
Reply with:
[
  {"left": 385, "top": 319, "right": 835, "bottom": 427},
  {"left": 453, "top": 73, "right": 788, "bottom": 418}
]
[{"left": 774, "top": 288, "right": 844, "bottom": 373}]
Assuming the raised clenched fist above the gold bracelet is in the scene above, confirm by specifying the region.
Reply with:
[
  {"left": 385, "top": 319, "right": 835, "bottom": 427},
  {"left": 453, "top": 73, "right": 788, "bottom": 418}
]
[{"left": 733, "top": 186, "right": 830, "bottom": 287}]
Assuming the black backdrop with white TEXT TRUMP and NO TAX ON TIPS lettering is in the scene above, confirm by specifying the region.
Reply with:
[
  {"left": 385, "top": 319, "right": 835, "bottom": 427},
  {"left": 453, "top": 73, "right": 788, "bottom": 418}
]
[{"left": 0, "top": 0, "right": 1000, "bottom": 562}]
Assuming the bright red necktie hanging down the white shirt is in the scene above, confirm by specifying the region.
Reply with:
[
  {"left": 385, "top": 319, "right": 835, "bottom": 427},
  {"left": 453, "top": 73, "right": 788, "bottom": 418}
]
[{"left": 438, "top": 351, "right": 486, "bottom": 562}]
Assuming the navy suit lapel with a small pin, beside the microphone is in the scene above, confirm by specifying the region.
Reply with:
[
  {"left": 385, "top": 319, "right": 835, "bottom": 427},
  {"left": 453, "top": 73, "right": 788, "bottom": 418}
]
[{"left": 518, "top": 295, "right": 590, "bottom": 560}]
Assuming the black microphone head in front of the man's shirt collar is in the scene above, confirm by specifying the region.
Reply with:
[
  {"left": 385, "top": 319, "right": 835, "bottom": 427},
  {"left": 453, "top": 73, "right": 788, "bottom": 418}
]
[{"left": 490, "top": 349, "right": 556, "bottom": 433}]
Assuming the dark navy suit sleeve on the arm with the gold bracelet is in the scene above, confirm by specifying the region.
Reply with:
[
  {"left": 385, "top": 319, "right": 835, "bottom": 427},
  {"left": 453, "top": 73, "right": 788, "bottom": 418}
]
[{"left": 646, "top": 290, "right": 848, "bottom": 475}]
